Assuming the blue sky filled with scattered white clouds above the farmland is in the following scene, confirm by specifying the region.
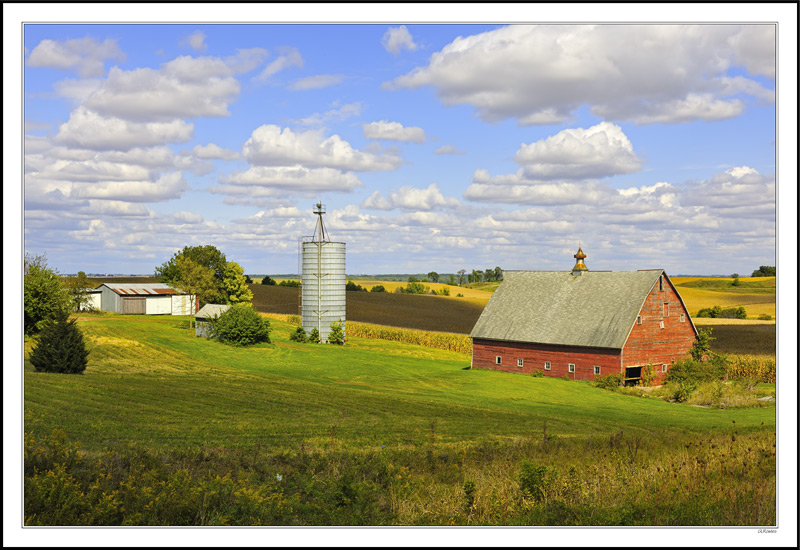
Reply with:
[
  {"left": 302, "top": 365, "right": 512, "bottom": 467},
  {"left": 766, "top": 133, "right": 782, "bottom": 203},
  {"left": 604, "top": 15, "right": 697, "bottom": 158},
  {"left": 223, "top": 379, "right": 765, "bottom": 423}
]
[{"left": 10, "top": 15, "right": 788, "bottom": 274}]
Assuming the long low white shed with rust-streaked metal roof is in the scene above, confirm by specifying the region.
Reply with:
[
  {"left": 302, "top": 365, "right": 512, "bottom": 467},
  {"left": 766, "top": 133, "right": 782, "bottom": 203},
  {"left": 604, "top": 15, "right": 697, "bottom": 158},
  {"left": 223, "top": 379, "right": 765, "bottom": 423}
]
[{"left": 97, "top": 283, "right": 197, "bottom": 315}]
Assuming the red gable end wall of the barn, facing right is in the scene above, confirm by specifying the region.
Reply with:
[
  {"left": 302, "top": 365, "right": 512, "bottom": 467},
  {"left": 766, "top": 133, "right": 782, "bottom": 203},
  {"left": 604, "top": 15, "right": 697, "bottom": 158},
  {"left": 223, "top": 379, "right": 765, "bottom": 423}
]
[{"left": 622, "top": 277, "right": 695, "bottom": 380}]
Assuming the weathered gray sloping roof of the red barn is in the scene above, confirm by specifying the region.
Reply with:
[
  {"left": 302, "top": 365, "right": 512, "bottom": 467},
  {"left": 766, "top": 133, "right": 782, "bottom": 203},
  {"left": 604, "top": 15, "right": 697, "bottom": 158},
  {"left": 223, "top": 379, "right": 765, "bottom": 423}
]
[{"left": 470, "top": 270, "right": 663, "bottom": 349}]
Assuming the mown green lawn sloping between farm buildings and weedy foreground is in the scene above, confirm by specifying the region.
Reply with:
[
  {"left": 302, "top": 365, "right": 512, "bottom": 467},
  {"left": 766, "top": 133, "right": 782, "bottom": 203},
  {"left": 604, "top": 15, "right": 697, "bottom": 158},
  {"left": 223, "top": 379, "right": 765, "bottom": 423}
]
[{"left": 25, "top": 316, "right": 775, "bottom": 451}]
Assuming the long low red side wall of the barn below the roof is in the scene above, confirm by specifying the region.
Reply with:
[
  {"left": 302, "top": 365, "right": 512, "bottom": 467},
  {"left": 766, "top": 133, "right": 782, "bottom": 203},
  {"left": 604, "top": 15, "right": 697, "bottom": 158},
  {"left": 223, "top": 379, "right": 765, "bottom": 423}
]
[{"left": 472, "top": 338, "right": 620, "bottom": 380}]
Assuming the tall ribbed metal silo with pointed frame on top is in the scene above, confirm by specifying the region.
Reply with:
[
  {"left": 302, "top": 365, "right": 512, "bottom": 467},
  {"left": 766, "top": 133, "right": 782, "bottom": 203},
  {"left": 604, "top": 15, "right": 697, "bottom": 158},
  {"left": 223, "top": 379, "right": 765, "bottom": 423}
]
[{"left": 300, "top": 202, "right": 347, "bottom": 342}]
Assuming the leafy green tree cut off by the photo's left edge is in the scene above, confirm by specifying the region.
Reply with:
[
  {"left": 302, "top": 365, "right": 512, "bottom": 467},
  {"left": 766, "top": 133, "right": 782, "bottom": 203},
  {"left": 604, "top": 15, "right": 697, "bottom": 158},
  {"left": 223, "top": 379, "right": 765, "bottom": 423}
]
[{"left": 24, "top": 254, "right": 71, "bottom": 335}]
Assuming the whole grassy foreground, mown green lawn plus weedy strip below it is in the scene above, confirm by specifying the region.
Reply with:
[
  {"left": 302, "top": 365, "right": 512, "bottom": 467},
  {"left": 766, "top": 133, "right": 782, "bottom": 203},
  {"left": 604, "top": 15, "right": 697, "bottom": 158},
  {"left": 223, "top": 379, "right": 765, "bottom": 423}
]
[{"left": 24, "top": 315, "right": 776, "bottom": 525}]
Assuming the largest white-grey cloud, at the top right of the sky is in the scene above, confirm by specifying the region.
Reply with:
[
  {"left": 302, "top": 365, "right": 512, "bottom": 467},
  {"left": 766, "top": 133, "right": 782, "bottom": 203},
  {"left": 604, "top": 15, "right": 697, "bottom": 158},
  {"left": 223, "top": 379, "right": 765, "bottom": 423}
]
[{"left": 384, "top": 24, "right": 775, "bottom": 125}]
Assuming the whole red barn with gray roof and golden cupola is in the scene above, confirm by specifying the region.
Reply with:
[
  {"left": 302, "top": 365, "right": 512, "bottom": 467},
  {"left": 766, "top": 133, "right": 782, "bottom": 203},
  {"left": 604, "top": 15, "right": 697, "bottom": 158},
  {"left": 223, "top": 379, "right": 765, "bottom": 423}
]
[{"left": 470, "top": 249, "right": 697, "bottom": 383}]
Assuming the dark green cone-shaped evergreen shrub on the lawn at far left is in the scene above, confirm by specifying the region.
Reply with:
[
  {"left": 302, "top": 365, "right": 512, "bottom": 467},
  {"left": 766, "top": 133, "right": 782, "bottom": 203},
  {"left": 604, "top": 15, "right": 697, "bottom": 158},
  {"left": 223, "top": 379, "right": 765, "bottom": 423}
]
[{"left": 30, "top": 312, "right": 89, "bottom": 374}]
